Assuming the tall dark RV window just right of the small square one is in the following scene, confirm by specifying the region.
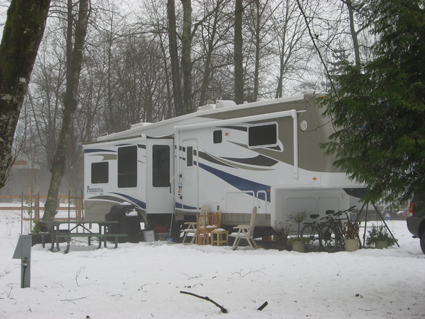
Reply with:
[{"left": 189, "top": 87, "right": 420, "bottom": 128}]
[{"left": 118, "top": 146, "right": 137, "bottom": 187}]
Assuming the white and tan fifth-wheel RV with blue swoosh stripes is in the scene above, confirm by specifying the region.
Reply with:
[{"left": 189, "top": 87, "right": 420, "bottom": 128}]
[{"left": 84, "top": 94, "right": 362, "bottom": 238}]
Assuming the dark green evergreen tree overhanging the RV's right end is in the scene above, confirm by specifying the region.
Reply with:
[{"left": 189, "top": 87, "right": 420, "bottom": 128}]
[{"left": 323, "top": 0, "right": 425, "bottom": 202}]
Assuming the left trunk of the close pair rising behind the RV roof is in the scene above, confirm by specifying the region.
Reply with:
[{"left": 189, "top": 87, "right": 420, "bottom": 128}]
[{"left": 167, "top": 0, "right": 183, "bottom": 115}]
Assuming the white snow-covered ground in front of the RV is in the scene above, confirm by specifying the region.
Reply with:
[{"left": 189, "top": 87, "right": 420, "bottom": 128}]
[{"left": 0, "top": 210, "right": 425, "bottom": 319}]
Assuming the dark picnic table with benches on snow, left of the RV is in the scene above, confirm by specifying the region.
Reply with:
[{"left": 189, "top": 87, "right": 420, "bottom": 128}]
[{"left": 43, "top": 220, "right": 127, "bottom": 254}]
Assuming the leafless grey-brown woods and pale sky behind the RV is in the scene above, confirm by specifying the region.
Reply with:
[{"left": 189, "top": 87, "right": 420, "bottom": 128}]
[{"left": 0, "top": 0, "right": 374, "bottom": 198}]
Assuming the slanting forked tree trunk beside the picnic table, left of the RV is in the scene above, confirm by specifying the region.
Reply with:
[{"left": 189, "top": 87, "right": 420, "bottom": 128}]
[{"left": 43, "top": 0, "right": 89, "bottom": 220}]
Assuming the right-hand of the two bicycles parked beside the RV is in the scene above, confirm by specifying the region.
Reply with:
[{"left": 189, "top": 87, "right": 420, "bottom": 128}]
[{"left": 319, "top": 206, "right": 355, "bottom": 252}]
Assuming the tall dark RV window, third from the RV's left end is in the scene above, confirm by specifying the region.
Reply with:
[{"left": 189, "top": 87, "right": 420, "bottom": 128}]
[{"left": 152, "top": 145, "right": 170, "bottom": 187}]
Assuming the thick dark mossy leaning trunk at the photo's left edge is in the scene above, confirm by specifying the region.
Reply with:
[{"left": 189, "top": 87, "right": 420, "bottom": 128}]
[{"left": 0, "top": 0, "right": 50, "bottom": 188}]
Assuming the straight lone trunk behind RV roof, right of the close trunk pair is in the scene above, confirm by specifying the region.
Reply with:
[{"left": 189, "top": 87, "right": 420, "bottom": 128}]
[{"left": 234, "top": 0, "right": 244, "bottom": 104}]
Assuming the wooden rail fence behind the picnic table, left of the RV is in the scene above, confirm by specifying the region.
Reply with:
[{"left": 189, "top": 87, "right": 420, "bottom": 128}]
[{"left": 0, "top": 192, "right": 84, "bottom": 221}]
